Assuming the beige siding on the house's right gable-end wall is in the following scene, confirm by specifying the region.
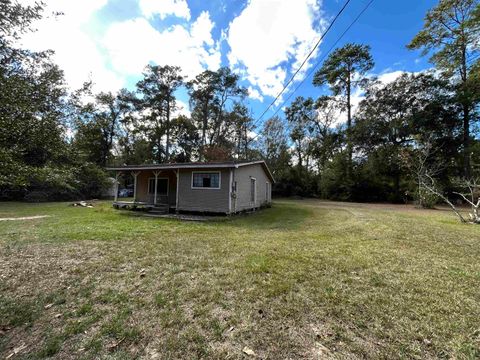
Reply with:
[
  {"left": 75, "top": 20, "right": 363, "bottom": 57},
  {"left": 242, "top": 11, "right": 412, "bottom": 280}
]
[{"left": 232, "top": 164, "right": 271, "bottom": 211}]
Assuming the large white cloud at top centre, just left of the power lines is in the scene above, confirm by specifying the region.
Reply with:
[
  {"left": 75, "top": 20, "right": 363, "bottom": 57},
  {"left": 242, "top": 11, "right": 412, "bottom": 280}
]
[{"left": 227, "top": 0, "right": 322, "bottom": 96}]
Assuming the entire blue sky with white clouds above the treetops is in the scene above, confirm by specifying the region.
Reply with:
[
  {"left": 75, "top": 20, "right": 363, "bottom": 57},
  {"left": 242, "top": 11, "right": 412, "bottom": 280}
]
[{"left": 20, "top": 0, "right": 436, "bottom": 125}]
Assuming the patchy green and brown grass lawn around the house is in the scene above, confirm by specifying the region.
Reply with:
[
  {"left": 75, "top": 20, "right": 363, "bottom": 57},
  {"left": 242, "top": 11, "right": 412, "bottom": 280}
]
[{"left": 0, "top": 200, "right": 480, "bottom": 359}]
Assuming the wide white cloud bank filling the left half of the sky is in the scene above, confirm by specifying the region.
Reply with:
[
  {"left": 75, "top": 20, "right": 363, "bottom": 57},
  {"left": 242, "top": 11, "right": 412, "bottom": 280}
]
[{"left": 15, "top": 0, "right": 221, "bottom": 91}]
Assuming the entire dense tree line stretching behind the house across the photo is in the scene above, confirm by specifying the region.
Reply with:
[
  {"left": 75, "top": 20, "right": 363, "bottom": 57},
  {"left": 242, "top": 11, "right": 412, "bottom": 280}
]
[{"left": 0, "top": 0, "right": 480, "bottom": 202}]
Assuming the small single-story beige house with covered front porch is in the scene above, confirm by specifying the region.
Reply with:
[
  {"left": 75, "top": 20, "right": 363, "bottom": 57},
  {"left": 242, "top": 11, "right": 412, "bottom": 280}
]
[{"left": 107, "top": 161, "right": 274, "bottom": 214}]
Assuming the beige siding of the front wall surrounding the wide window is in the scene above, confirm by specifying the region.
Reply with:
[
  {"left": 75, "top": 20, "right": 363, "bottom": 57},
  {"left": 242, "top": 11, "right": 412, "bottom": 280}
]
[{"left": 178, "top": 168, "right": 230, "bottom": 213}]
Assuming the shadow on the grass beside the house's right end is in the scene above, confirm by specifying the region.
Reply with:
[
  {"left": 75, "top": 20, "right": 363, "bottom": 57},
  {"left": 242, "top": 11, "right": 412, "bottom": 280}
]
[{"left": 225, "top": 202, "right": 313, "bottom": 230}]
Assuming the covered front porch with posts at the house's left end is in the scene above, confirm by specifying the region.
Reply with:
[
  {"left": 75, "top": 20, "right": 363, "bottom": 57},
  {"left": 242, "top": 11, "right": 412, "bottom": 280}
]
[{"left": 113, "top": 169, "right": 178, "bottom": 212}]
